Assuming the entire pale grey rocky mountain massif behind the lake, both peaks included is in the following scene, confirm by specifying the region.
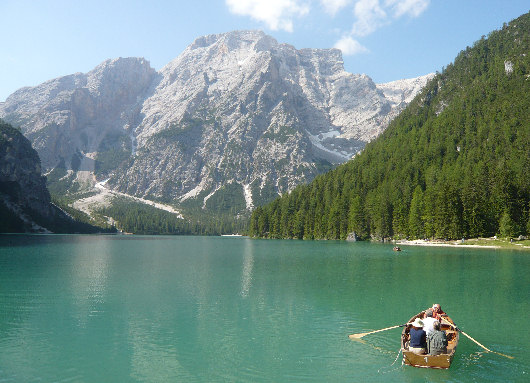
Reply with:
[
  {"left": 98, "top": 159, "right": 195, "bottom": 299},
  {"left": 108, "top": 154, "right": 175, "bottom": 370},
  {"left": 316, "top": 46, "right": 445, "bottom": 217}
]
[{"left": 0, "top": 31, "right": 432, "bottom": 216}]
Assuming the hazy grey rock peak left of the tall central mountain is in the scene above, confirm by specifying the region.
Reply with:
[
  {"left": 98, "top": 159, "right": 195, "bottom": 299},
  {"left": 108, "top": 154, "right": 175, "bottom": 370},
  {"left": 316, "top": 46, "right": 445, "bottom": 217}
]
[{"left": 0, "top": 58, "right": 156, "bottom": 170}]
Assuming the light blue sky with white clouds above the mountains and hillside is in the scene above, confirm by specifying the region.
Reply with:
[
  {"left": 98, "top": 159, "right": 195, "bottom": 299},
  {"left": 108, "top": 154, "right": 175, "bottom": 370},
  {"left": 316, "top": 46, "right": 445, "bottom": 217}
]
[{"left": 0, "top": 0, "right": 530, "bottom": 102}]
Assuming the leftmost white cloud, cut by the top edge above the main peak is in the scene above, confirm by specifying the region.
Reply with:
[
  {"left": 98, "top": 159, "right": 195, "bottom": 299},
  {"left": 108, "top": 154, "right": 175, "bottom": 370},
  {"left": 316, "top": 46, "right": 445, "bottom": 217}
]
[{"left": 225, "top": 0, "right": 309, "bottom": 32}]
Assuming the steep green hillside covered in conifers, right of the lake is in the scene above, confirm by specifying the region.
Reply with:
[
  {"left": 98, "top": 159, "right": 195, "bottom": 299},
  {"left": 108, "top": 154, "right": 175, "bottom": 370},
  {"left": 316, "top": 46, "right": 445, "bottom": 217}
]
[{"left": 249, "top": 13, "right": 530, "bottom": 239}]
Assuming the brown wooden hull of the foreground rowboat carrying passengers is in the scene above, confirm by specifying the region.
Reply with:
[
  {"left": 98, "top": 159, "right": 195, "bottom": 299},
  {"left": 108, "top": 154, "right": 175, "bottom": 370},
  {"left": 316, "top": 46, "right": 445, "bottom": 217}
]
[{"left": 401, "top": 311, "right": 459, "bottom": 368}]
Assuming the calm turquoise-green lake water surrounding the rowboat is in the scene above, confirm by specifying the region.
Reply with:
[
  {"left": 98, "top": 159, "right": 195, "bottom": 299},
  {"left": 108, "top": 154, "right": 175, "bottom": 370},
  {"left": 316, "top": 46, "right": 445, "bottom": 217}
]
[{"left": 0, "top": 235, "right": 530, "bottom": 382}]
